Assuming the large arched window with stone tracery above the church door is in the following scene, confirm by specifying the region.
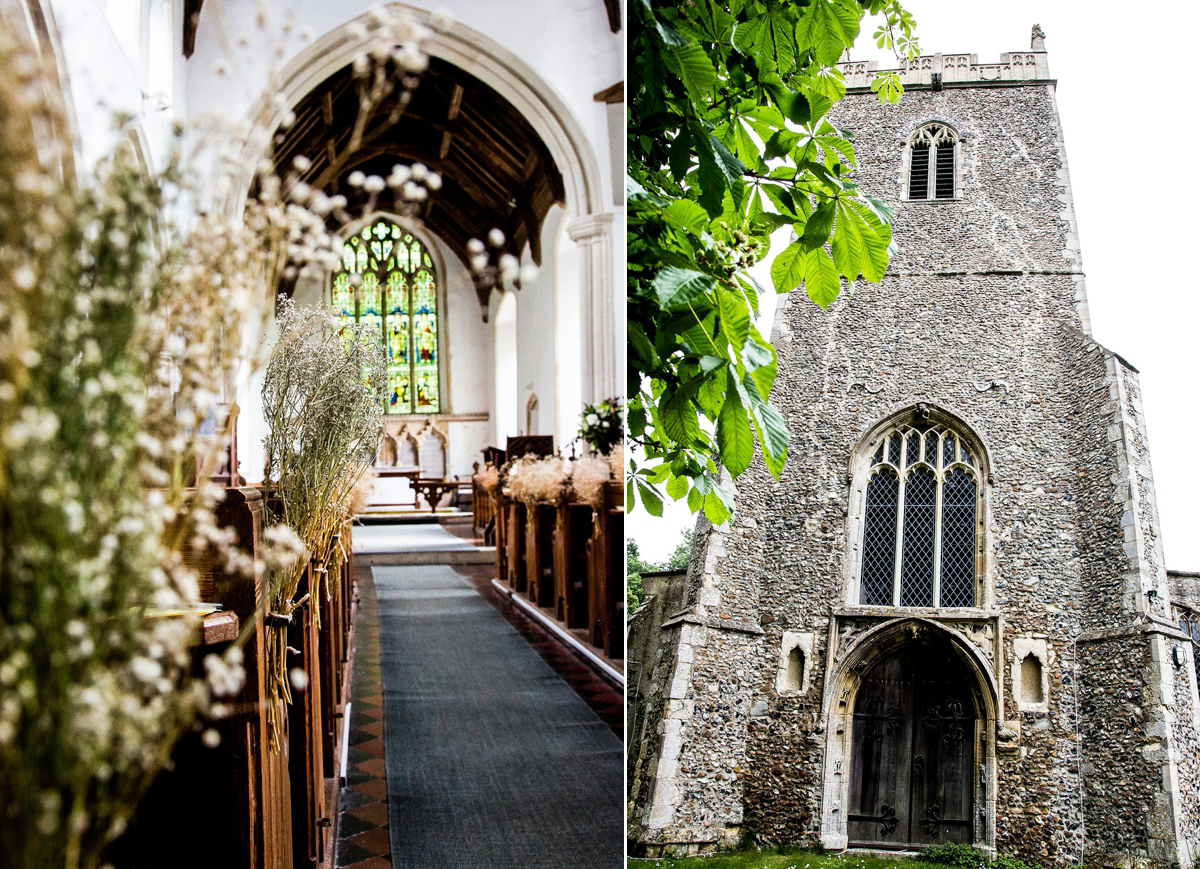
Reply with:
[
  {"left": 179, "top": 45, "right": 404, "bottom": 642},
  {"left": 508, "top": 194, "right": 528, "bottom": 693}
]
[{"left": 858, "top": 422, "right": 983, "bottom": 606}]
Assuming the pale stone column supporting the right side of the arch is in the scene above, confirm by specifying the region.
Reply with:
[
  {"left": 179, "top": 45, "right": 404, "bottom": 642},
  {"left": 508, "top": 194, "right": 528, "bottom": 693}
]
[{"left": 566, "top": 212, "right": 620, "bottom": 404}]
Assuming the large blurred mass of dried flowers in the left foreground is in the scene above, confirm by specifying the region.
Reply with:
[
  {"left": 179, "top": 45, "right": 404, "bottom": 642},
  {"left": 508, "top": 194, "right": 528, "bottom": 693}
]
[{"left": 0, "top": 28, "right": 319, "bottom": 869}]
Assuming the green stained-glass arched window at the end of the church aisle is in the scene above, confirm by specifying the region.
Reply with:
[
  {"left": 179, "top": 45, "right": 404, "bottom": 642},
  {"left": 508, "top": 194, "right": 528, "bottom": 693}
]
[{"left": 332, "top": 217, "right": 442, "bottom": 414}]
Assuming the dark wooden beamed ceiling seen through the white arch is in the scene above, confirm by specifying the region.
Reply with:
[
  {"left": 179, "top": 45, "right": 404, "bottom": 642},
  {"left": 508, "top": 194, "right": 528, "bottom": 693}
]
[{"left": 275, "top": 58, "right": 565, "bottom": 308}]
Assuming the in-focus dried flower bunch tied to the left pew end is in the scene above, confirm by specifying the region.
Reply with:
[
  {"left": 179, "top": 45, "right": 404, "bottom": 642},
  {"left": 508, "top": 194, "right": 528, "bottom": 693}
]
[{"left": 263, "top": 296, "right": 386, "bottom": 739}]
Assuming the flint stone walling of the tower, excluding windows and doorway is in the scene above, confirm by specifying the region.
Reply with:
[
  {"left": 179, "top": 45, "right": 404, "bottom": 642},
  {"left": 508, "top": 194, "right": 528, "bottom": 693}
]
[{"left": 631, "top": 64, "right": 1200, "bottom": 867}]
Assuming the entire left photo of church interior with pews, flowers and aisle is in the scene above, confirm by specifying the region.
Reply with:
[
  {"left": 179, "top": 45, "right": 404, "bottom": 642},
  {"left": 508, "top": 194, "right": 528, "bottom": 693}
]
[{"left": 0, "top": 0, "right": 625, "bottom": 869}]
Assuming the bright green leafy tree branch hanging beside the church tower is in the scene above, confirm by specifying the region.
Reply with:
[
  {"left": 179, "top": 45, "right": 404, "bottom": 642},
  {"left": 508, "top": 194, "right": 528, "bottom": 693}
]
[{"left": 626, "top": 0, "right": 918, "bottom": 523}]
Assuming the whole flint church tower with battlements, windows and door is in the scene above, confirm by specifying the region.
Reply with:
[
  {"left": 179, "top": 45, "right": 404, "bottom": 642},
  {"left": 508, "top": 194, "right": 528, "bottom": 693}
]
[{"left": 629, "top": 28, "right": 1200, "bottom": 869}]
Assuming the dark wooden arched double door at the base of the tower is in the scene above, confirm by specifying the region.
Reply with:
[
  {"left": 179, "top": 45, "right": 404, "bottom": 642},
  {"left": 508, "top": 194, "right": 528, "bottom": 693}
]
[{"left": 847, "top": 643, "right": 976, "bottom": 847}]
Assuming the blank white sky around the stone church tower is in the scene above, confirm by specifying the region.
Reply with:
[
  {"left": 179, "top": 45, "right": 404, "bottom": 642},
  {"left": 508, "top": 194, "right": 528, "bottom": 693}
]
[{"left": 628, "top": 0, "right": 1200, "bottom": 570}]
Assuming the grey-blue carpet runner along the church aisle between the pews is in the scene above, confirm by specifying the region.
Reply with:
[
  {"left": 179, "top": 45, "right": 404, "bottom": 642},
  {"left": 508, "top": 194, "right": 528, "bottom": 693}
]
[{"left": 372, "top": 565, "right": 624, "bottom": 869}]
